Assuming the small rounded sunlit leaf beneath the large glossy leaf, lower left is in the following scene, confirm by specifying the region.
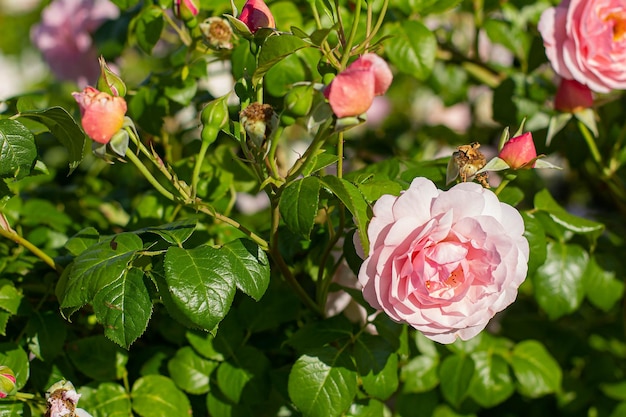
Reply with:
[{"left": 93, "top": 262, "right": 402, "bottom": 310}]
[{"left": 167, "top": 346, "right": 218, "bottom": 394}]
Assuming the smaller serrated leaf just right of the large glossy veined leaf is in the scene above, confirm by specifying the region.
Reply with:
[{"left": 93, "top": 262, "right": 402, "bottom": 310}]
[{"left": 220, "top": 239, "right": 270, "bottom": 301}]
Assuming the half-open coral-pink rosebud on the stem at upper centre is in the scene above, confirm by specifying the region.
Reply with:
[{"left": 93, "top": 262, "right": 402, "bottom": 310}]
[{"left": 324, "top": 53, "right": 393, "bottom": 118}]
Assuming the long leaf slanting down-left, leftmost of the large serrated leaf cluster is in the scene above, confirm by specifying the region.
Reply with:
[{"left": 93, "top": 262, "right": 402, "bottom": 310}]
[{"left": 61, "top": 233, "right": 143, "bottom": 308}]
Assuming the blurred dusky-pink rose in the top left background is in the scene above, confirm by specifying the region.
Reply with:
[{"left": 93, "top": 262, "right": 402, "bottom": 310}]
[{"left": 31, "top": 0, "right": 119, "bottom": 87}]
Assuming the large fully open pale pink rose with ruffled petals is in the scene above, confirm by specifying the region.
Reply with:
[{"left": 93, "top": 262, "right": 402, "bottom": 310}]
[{"left": 359, "top": 178, "right": 529, "bottom": 343}]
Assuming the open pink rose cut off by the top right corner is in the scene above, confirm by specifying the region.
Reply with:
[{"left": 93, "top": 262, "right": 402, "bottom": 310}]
[{"left": 538, "top": 0, "right": 626, "bottom": 93}]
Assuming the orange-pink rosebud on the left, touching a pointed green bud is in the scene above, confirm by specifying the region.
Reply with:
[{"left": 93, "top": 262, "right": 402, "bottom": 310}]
[{"left": 72, "top": 87, "right": 127, "bottom": 143}]
